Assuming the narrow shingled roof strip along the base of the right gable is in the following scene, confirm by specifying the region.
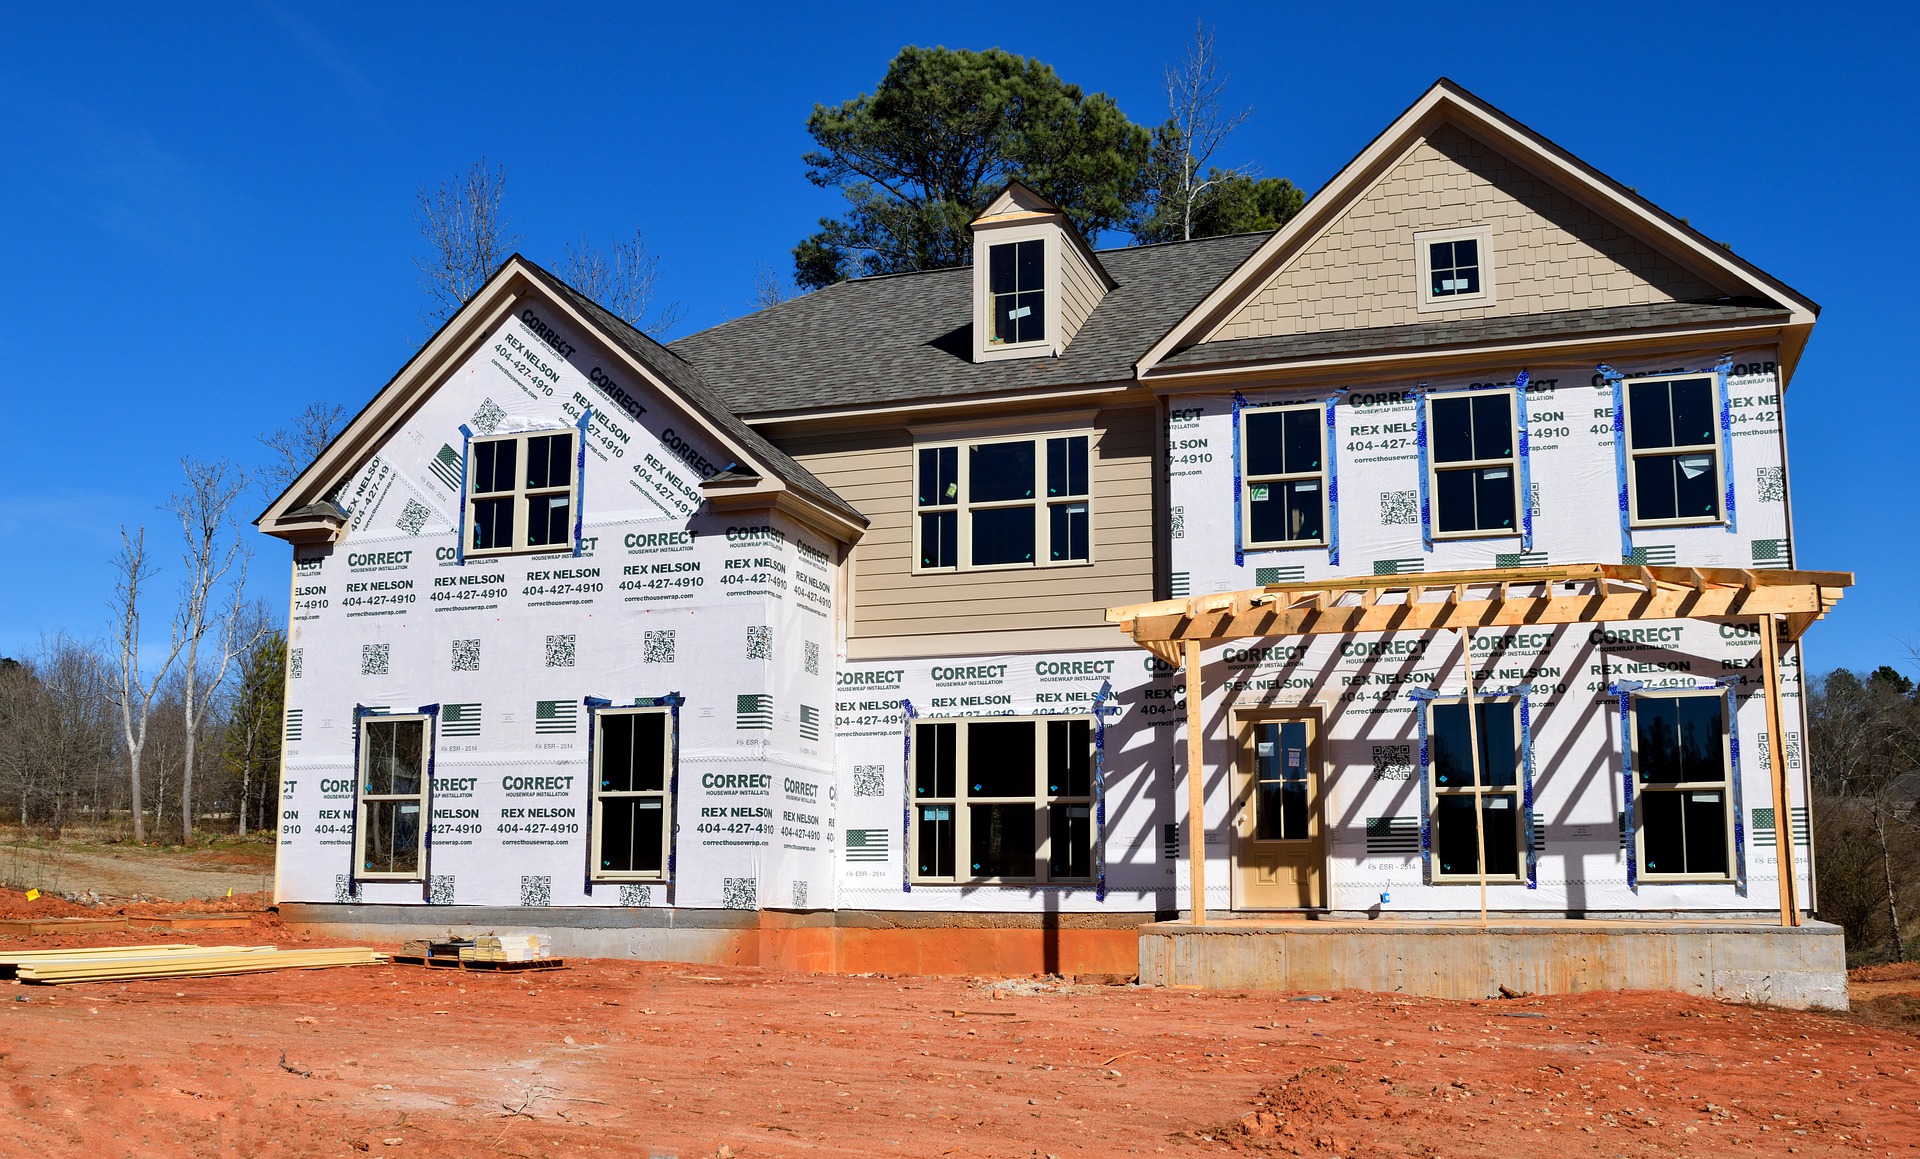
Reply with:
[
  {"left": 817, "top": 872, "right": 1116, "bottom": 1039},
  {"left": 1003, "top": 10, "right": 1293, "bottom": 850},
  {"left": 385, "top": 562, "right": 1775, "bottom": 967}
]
[{"left": 1160, "top": 301, "right": 1788, "bottom": 368}]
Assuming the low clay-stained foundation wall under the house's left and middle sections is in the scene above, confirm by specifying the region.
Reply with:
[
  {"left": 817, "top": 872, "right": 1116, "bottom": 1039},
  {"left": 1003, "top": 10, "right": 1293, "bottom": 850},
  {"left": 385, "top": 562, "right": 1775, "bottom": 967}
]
[{"left": 280, "top": 902, "right": 1154, "bottom": 979}]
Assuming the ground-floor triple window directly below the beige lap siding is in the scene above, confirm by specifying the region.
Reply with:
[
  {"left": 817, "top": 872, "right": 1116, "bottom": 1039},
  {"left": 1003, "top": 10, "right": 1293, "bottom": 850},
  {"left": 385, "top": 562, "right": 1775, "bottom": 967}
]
[{"left": 912, "top": 716, "right": 1092, "bottom": 881}]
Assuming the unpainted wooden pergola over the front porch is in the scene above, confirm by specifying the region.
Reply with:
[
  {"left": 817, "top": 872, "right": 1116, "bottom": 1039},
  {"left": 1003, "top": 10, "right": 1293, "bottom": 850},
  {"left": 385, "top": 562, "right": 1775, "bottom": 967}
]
[{"left": 1106, "top": 564, "right": 1853, "bottom": 925}]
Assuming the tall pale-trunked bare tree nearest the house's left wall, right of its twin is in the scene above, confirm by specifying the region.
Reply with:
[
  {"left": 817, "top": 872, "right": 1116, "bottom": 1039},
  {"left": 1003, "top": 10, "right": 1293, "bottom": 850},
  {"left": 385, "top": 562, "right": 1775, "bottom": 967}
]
[{"left": 167, "top": 459, "right": 261, "bottom": 842}]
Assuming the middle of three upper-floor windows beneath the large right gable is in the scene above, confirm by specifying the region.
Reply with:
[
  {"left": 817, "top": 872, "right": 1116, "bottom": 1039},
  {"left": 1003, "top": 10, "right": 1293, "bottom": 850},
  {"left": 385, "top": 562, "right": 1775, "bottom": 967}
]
[{"left": 1427, "top": 390, "right": 1521, "bottom": 537}]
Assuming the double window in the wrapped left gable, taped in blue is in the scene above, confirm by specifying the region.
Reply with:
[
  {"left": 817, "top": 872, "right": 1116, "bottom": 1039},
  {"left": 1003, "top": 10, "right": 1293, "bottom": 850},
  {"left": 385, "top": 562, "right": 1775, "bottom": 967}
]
[{"left": 467, "top": 430, "right": 576, "bottom": 555}]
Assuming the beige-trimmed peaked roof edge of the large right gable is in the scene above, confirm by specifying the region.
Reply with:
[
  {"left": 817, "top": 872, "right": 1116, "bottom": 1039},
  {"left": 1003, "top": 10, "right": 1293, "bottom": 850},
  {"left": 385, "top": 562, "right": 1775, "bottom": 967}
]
[{"left": 1137, "top": 77, "right": 1820, "bottom": 378}]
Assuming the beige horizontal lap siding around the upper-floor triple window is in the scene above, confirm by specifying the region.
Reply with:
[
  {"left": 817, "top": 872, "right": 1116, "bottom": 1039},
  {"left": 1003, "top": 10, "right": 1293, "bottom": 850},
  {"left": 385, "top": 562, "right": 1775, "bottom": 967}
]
[{"left": 776, "top": 407, "right": 1156, "bottom": 637}]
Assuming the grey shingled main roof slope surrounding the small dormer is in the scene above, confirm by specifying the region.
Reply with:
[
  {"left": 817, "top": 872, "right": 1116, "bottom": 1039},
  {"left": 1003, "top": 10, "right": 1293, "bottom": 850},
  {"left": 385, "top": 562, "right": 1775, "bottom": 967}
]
[{"left": 668, "top": 234, "right": 1269, "bottom": 418}]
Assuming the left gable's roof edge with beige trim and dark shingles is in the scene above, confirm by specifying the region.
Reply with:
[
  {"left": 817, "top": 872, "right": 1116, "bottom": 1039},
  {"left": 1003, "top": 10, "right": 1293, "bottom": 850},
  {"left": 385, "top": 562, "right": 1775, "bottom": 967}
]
[{"left": 253, "top": 253, "right": 866, "bottom": 539}]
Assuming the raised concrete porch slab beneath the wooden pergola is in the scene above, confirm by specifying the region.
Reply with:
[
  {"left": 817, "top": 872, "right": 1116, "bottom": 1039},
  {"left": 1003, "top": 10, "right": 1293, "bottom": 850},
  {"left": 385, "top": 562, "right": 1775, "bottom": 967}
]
[{"left": 1140, "top": 919, "right": 1847, "bottom": 1009}]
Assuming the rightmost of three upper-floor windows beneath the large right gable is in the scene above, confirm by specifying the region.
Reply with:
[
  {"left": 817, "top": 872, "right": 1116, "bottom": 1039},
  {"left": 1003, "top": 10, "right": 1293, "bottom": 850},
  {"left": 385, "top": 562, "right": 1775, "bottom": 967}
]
[{"left": 1626, "top": 376, "right": 1720, "bottom": 526}]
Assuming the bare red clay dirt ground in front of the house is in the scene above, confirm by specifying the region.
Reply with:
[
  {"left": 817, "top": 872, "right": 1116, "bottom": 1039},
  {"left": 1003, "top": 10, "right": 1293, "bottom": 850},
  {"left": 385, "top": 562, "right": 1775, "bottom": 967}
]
[{"left": 0, "top": 894, "right": 1920, "bottom": 1159}]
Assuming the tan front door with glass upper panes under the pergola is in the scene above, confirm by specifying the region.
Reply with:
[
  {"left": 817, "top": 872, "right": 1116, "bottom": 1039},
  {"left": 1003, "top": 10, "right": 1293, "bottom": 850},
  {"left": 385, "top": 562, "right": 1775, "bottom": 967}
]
[{"left": 1233, "top": 716, "right": 1327, "bottom": 910}]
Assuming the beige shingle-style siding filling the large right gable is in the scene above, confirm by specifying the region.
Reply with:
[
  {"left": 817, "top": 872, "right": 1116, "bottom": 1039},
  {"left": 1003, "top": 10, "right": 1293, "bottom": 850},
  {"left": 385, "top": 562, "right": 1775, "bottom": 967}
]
[{"left": 1208, "top": 125, "right": 1720, "bottom": 342}]
